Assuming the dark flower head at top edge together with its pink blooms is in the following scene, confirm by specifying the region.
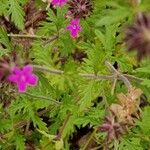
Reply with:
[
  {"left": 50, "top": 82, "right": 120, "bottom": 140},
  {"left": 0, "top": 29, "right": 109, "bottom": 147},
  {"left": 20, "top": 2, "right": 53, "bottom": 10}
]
[{"left": 44, "top": 0, "right": 87, "bottom": 38}]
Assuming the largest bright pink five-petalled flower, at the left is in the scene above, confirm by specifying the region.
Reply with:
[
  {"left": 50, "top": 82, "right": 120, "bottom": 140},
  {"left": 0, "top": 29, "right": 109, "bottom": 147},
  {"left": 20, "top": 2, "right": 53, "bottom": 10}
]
[{"left": 8, "top": 65, "right": 38, "bottom": 93}]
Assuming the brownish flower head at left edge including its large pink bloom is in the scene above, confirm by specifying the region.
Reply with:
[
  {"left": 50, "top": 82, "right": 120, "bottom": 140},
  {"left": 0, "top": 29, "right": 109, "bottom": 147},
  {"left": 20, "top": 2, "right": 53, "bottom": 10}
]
[{"left": 0, "top": 51, "right": 38, "bottom": 93}]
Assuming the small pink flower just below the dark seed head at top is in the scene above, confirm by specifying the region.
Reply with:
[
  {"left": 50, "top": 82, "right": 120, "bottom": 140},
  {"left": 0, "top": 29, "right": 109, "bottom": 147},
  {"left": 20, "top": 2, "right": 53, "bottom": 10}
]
[{"left": 66, "top": 18, "right": 81, "bottom": 38}]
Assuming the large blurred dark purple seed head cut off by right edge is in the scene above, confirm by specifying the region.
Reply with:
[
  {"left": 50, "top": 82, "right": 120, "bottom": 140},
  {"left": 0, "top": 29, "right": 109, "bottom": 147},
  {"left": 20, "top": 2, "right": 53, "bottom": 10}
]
[{"left": 125, "top": 13, "right": 150, "bottom": 61}]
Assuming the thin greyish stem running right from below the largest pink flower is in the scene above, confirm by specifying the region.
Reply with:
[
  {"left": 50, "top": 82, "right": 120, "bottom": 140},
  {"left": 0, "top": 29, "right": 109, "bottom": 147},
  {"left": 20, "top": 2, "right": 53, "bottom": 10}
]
[{"left": 24, "top": 92, "right": 60, "bottom": 105}]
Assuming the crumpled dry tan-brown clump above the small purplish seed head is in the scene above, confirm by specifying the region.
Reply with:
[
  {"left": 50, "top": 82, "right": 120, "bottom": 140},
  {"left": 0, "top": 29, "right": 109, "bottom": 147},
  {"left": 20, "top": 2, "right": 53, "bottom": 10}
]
[{"left": 110, "top": 88, "right": 142, "bottom": 125}]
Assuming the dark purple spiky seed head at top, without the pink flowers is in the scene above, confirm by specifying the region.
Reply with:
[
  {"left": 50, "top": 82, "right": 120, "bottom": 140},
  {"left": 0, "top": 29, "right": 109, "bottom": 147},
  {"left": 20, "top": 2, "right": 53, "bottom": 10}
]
[{"left": 66, "top": 0, "right": 93, "bottom": 18}]
